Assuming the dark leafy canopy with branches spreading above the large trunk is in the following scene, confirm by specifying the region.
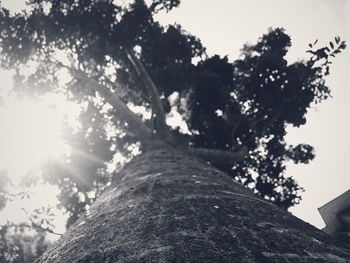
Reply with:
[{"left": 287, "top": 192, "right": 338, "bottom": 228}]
[{"left": 0, "top": 0, "right": 345, "bottom": 262}]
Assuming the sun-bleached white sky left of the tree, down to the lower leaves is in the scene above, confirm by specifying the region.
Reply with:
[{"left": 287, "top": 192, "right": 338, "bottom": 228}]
[{"left": 0, "top": 94, "right": 80, "bottom": 233}]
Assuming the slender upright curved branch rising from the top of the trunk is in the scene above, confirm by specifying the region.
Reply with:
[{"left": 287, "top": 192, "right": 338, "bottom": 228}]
[{"left": 125, "top": 49, "right": 169, "bottom": 138}]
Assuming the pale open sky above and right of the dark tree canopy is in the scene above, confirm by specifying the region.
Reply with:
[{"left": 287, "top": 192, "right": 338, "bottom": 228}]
[{"left": 2, "top": 0, "right": 350, "bottom": 230}]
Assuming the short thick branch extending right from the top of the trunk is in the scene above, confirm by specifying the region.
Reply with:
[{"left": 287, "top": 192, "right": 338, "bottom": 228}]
[{"left": 187, "top": 146, "right": 248, "bottom": 166}]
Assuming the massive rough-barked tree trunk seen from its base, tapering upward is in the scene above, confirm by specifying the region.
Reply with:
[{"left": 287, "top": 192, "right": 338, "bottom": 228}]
[{"left": 38, "top": 149, "right": 350, "bottom": 263}]
